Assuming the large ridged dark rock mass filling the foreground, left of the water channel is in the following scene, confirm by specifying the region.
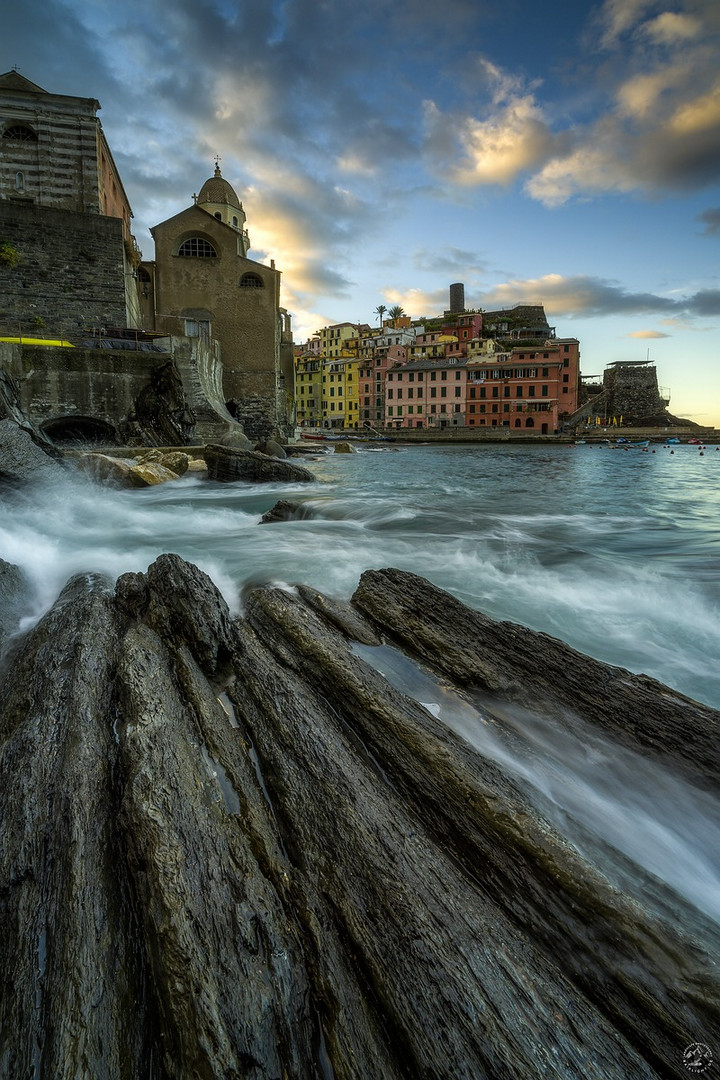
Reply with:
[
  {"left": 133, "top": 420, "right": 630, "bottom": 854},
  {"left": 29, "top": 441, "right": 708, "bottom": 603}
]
[{"left": 0, "top": 555, "right": 720, "bottom": 1080}]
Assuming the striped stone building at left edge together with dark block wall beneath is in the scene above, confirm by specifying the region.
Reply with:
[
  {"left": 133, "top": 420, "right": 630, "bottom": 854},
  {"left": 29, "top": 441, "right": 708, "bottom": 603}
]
[{"left": 0, "top": 71, "right": 139, "bottom": 336}]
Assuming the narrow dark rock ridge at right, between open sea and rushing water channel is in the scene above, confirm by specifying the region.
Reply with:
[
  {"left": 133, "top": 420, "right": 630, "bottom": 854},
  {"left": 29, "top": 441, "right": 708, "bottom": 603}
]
[{"left": 353, "top": 569, "right": 720, "bottom": 789}]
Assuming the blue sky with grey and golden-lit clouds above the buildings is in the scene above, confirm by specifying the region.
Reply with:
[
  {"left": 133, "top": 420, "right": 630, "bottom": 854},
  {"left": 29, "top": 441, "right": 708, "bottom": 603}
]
[{"left": 5, "top": 0, "right": 720, "bottom": 427}]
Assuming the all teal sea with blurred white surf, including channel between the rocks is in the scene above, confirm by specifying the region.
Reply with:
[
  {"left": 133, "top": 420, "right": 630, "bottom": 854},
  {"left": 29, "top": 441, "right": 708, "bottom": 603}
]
[{"left": 0, "top": 444, "right": 720, "bottom": 921}]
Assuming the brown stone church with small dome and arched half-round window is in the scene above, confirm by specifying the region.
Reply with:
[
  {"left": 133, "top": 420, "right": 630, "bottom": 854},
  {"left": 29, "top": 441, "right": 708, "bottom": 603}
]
[{"left": 138, "top": 165, "right": 293, "bottom": 438}]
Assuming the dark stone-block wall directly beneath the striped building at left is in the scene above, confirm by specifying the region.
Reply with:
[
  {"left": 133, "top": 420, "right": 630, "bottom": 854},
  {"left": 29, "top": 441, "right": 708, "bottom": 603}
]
[{"left": 0, "top": 201, "right": 126, "bottom": 342}]
